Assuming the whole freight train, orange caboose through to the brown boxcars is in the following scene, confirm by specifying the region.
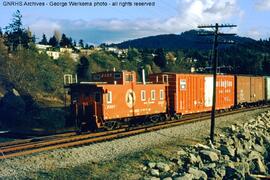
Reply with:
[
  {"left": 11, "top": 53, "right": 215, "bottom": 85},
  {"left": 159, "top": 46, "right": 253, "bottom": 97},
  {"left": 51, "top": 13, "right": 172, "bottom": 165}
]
[{"left": 66, "top": 70, "right": 270, "bottom": 132}]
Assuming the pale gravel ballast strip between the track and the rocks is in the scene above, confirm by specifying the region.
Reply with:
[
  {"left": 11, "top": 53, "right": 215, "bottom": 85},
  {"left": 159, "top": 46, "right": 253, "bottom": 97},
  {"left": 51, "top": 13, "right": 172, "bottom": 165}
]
[{"left": 0, "top": 108, "right": 270, "bottom": 179}]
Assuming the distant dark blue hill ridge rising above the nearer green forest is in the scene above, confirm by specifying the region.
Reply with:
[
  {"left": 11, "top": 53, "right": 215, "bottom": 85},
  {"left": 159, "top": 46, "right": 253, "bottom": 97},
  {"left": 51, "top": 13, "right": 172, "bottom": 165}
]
[{"left": 110, "top": 30, "right": 256, "bottom": 50}]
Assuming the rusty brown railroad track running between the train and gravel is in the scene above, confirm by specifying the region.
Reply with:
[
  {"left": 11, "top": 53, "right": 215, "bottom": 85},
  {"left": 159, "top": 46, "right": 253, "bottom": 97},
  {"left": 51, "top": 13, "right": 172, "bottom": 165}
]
[{"left": 0, "top": 106, "right": 269, "bottom": 159}]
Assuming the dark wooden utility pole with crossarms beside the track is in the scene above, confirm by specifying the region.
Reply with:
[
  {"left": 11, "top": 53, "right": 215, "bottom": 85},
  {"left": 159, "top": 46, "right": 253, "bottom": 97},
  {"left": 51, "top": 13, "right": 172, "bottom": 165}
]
[{"left": 198, "top": 23, "right": 236, "bottom": 144}]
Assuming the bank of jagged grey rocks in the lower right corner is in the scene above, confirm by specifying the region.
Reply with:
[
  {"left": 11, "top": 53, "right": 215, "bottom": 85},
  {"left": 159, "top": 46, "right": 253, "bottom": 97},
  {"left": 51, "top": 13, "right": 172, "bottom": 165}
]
[{"left": 144, "top": 111, "right": 270, "bottom": 180}]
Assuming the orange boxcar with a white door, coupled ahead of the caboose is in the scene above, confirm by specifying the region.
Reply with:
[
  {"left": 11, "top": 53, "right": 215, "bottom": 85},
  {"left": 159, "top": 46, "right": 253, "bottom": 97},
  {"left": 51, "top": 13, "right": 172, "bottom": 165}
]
[{"left": 149, "top": 73, "right": 234, "bottom": 114}]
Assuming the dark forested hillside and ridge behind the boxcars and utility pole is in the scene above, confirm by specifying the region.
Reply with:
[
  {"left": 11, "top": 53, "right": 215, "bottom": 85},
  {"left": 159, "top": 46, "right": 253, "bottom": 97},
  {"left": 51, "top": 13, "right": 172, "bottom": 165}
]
[{"left": 110, "top": 30, "right": 270, "bottom": 75}]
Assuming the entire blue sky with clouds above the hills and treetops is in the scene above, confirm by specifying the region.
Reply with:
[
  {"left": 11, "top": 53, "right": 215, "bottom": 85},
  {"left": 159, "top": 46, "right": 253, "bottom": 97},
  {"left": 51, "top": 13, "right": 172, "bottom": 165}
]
[{"left": 0, "top": 0, "right": 270, "bottom": 44}]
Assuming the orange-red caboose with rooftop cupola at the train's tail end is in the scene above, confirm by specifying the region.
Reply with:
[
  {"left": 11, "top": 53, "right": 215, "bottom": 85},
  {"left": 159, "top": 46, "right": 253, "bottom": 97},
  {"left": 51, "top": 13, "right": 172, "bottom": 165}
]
[{"left": 68, "top": 71, "right": 168, "bottom": 131}]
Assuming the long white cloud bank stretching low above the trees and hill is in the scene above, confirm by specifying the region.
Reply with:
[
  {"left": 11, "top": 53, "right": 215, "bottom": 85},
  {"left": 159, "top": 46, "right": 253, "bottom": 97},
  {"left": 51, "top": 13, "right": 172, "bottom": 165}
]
[{"left": 30, "top": 0, "right": 243, "bottom": 42}]
